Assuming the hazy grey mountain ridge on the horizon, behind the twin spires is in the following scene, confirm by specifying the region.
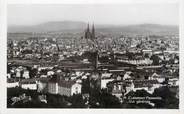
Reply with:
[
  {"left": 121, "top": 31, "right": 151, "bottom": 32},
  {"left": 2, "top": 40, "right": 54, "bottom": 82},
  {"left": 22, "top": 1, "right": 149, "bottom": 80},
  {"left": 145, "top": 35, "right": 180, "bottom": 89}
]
[{"left": 8, "top": 21, "right": 179, "bottom": 33}]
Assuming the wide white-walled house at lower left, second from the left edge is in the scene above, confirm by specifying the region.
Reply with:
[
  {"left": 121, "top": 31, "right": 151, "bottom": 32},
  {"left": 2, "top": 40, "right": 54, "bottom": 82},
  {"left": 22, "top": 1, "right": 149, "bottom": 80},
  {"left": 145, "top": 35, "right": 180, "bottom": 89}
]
[{"left": 19, "top": 78, "right": 37, "bottom": 90}]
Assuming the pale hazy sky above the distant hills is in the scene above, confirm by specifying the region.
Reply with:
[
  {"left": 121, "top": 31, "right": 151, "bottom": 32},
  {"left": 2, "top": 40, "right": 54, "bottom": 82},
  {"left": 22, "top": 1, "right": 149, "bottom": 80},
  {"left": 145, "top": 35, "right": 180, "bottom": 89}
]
[{"left": 7, "top": 3, "right": 179, "bottom": 25}]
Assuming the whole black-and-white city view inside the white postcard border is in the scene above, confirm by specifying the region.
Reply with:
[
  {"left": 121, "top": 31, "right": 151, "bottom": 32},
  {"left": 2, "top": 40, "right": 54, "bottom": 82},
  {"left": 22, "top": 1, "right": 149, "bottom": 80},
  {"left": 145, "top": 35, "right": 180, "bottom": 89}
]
[{"left": 0, "top": 2, "right": 182, "bottom": 110}]
